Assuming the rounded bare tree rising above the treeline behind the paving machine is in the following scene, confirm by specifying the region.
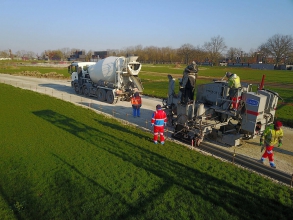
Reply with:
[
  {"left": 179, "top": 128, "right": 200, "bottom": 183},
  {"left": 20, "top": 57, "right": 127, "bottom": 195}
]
[{"left": 203, "top": 35, "right": 227, "bottom": 65}]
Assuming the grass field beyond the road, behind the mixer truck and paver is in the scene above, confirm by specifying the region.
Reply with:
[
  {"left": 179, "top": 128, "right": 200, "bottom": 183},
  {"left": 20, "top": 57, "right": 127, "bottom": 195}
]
[{"left": 0, "top": 61, "right": 293, "bottom": 127}]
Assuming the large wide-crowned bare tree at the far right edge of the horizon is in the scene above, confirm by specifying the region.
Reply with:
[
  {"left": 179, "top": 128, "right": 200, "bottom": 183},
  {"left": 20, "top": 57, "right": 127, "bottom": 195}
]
[{"left": 258, "top": 34, "right": 293, "bottom": 66}]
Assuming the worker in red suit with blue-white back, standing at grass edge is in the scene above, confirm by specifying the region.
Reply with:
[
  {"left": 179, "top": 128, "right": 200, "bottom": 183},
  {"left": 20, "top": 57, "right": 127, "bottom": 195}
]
[{"left": 151, "top": 105, "right": 167, "bottom": 144}]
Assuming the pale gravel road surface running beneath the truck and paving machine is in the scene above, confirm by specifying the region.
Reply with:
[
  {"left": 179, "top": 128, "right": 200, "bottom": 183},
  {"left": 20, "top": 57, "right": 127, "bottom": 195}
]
[{"left": 0, "top": 74, "right": 293, "bottom": 174}]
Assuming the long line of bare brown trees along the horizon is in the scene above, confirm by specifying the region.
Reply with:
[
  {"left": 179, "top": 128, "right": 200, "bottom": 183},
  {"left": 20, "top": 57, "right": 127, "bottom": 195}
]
[{"left": 0, "top": 34, "right": 293, "bottom": 65}]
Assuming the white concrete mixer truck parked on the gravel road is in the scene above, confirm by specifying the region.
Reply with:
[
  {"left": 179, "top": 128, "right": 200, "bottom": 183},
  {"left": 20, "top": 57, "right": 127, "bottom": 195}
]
[{"left": 68, "top": 56, "right": 143, "bottom": 104}]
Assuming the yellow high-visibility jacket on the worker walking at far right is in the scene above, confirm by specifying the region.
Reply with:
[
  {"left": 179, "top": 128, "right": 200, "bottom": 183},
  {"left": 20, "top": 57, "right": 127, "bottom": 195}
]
[{"left": 260, "top": 125, "right": 284, "bottom": 146}]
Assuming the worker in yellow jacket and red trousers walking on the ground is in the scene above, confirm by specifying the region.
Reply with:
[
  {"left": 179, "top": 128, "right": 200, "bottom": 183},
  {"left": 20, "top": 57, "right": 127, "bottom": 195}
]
[{"left": 260, "top": 121, "right": 283, "bottom": 168}]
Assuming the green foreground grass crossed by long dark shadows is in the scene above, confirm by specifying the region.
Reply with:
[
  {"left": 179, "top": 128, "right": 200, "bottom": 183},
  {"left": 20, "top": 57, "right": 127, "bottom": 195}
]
[{"left": 0, "top": 84, "right": 293, "bottom": 220}]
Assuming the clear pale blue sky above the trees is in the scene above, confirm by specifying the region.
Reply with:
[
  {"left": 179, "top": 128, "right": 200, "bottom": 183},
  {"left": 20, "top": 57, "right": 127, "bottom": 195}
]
[{"left": 0, "top": 0, "right": 293, "bottom": 54}]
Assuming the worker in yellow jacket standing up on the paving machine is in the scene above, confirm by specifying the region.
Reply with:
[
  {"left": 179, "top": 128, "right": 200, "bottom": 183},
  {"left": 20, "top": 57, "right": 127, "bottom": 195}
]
[{"left": 226, "top": 72, "right": 241, "bottom": 111}]
